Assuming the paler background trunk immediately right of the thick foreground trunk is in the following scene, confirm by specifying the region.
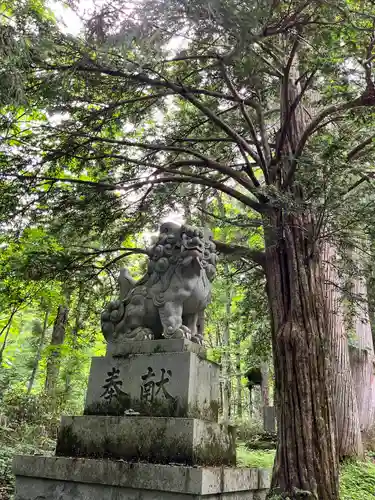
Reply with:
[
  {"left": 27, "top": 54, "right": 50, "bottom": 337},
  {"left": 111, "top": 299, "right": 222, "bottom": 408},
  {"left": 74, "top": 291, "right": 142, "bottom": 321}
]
[{"left": 323, "top": 244, "right": 363, "bottom": 459}]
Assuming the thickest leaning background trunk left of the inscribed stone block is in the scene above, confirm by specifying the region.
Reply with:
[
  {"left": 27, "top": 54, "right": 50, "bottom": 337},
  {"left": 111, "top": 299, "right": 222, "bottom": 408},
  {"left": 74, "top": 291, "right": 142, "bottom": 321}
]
[{"left": 45, "top": 305, "right": 69, "bottom": 396}]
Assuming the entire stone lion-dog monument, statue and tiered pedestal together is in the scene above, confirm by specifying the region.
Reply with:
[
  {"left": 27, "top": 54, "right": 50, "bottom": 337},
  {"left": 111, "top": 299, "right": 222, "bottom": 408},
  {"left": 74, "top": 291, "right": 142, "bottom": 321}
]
[{"left": 14, "top": 223, "right": 269, "bottom": 500}]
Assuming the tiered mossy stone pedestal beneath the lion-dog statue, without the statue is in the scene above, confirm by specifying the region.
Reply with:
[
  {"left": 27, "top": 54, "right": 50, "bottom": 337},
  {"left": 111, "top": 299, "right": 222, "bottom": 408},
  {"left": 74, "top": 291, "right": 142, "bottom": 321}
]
[{"left": 14, "top": 340, "right": 269, "bottom": 500}]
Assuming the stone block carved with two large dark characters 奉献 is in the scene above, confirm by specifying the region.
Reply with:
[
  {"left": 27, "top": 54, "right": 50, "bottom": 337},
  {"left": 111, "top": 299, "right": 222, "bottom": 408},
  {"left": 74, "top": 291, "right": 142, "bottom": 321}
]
[{"left": 85, "top": 351, "right": 220, "bottom": 421}]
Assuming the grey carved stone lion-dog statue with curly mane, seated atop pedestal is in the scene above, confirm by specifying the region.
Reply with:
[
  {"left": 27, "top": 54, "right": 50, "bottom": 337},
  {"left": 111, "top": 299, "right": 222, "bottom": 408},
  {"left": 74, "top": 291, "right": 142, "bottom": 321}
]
[{"left": 101, "top": 222, "right": 217, "bottom": 344}]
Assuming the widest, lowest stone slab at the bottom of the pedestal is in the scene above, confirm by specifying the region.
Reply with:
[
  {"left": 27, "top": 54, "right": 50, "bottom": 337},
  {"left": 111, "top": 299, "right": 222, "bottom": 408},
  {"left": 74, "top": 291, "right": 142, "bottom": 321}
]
[{"left": 13, "top": 456, "right": 270, "bottom": 500}]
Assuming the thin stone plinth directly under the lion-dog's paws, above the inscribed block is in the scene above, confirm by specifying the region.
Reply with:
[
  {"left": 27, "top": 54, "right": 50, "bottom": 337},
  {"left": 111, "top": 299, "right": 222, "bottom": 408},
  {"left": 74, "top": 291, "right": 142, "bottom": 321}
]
[{"left": 107, "top": 337, "right": 207, "bottom": 359}]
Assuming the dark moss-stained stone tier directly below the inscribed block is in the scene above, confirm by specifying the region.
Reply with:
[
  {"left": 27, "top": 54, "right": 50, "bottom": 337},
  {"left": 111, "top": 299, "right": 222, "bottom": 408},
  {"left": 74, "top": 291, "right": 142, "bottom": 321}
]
[{"left": 56, "top": 415, "right": 236, "bottom": 465}]
